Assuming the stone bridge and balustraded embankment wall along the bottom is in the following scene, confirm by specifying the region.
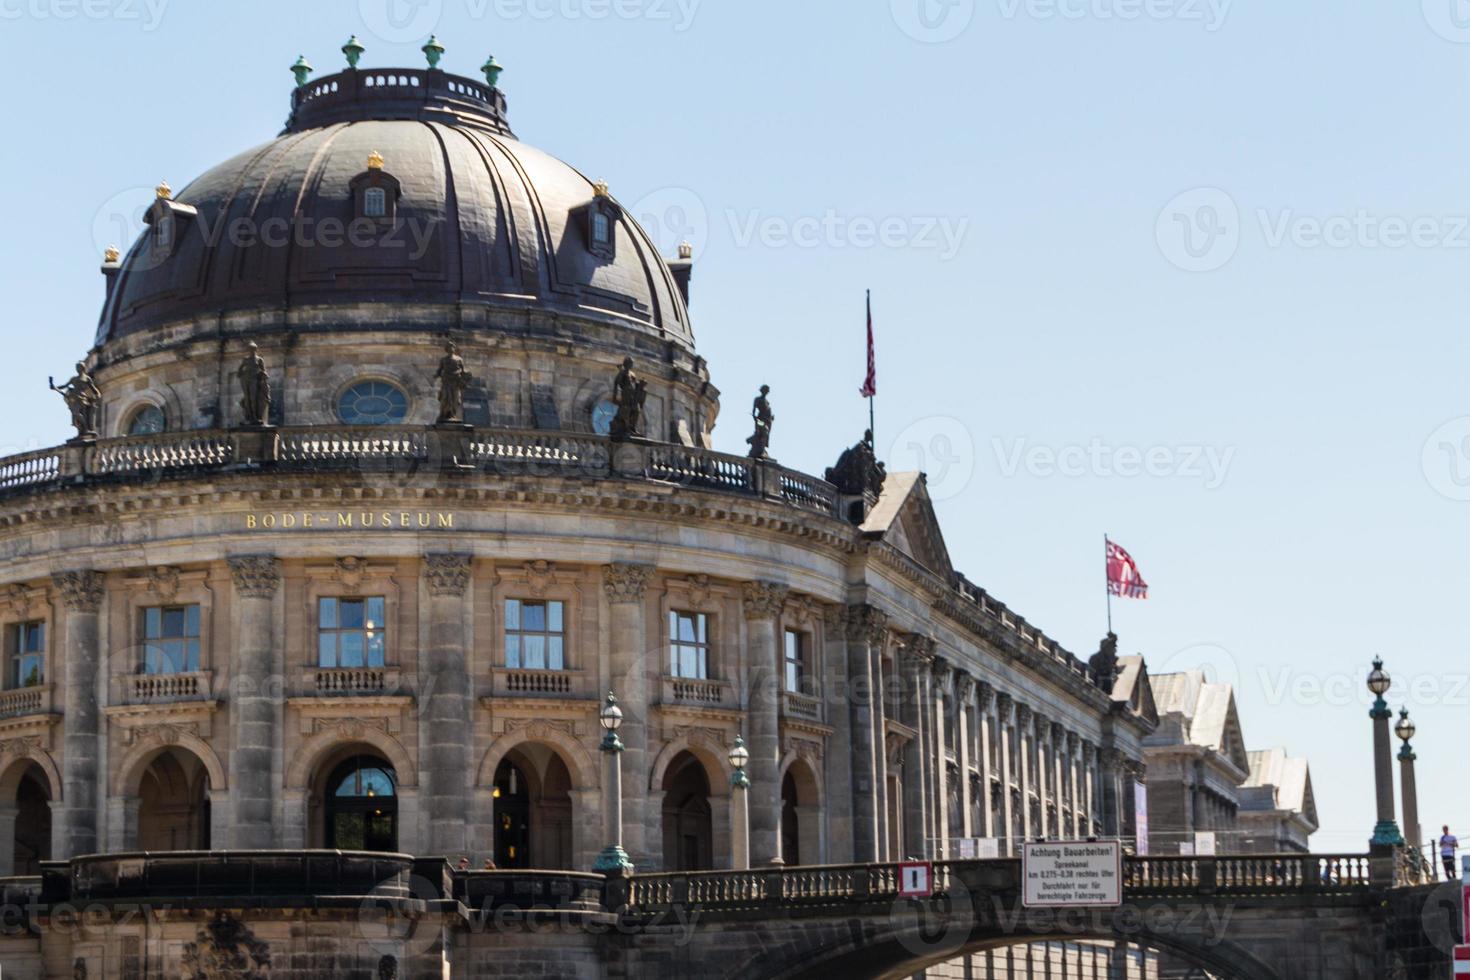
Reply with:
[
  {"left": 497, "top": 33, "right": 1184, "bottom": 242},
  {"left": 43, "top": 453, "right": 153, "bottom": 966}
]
[{"left": 0, "top": 851, "right": 1460, "bottom": 980}]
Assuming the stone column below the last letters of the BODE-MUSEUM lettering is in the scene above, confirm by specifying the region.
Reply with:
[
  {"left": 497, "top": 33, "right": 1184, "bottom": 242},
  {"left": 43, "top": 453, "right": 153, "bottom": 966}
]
[{"left": 419, "top": 554, "right": 475, "bottom": 860}]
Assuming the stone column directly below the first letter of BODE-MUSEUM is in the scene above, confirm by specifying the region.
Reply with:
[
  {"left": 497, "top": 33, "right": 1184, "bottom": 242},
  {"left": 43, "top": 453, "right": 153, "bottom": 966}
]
[{"left": 221, "top": 555, "right": 282, "bottom": 851}]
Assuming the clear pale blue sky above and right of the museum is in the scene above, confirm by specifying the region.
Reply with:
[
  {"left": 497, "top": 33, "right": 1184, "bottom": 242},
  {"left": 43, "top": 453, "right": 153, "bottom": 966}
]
[{"left": 0, "top": 0, "right": 1470, "bottom": 849}]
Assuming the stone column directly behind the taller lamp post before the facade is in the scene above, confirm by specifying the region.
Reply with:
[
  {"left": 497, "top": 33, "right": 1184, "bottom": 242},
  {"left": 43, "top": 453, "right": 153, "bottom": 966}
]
[{"left": 603, "top": 563, "right": 663, "bottom": 867}]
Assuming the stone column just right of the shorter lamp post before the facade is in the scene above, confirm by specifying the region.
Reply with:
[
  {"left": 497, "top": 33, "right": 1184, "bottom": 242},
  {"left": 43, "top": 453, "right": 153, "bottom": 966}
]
[{"left": 741, "top": 582, "right": 786, "bottom": 867}]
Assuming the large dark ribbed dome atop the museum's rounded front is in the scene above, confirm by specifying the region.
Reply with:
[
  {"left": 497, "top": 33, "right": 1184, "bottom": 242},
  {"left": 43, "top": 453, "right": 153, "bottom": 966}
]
[{"left": 97, "top": 69, "right": 694, "bottom": 348}]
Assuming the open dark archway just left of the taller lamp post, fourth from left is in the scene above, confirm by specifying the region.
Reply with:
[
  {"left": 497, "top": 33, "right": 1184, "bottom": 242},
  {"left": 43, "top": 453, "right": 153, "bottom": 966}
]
[{"left": 491, "top": 742, "right": 573, "bottom": 870}]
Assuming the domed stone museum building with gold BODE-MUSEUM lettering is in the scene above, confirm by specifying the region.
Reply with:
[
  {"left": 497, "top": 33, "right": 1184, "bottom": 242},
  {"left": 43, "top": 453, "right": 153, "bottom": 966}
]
[{"left": 0, "top": 41, "right": 1328, "bottom": 980}]
